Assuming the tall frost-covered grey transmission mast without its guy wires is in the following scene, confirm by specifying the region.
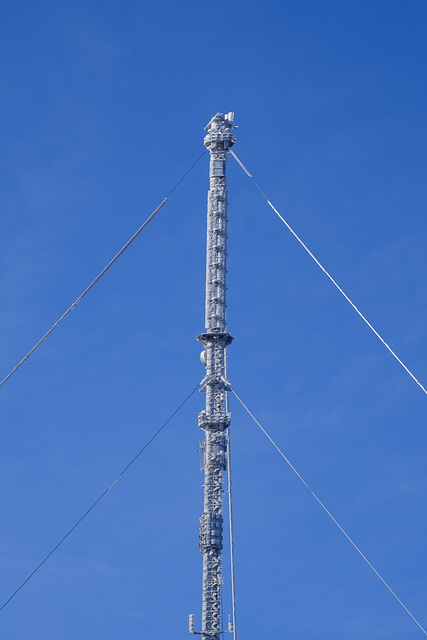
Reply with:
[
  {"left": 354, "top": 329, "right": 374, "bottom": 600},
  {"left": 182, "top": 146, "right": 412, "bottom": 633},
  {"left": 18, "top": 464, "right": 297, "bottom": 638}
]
[{"left": 189, "top": 113, "right": 236, "bottom": 640}]
